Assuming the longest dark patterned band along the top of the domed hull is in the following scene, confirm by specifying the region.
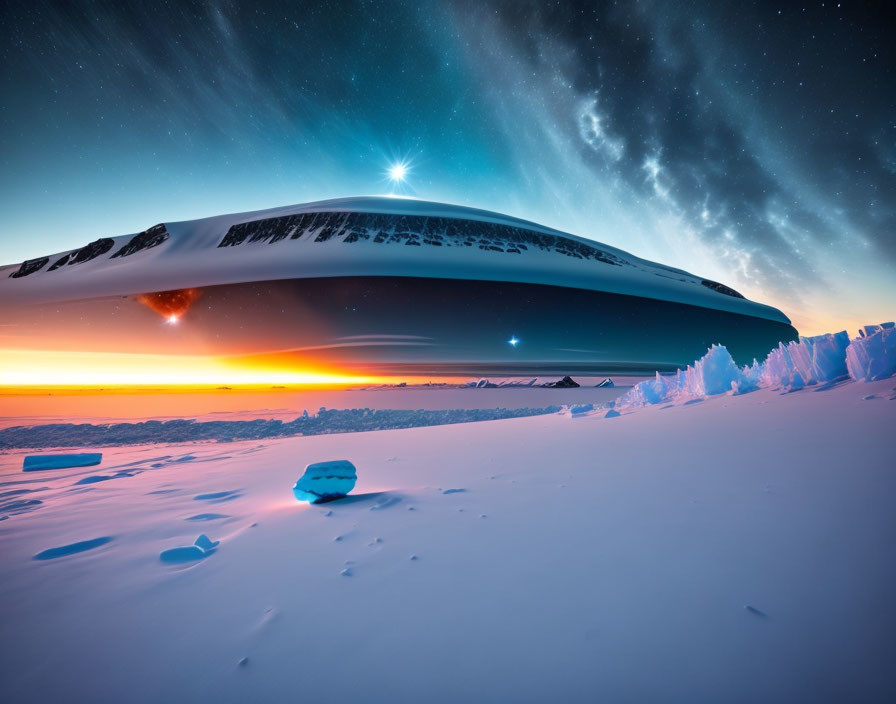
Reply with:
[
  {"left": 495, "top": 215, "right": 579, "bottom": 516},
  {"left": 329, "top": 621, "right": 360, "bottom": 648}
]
[{"left": 218, "top": 212, "right": 630, "bottom": 266}]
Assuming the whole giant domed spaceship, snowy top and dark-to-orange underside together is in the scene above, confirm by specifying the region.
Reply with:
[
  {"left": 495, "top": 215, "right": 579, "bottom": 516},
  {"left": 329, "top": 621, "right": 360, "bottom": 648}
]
[{"left": 0, "top": 197, "right": 797, "bottom": 375}]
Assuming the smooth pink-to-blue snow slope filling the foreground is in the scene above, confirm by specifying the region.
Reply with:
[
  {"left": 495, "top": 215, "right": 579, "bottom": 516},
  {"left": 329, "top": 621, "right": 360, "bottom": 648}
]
[{"left": 0, "top": 376, "right": 896, "bottom": 702}]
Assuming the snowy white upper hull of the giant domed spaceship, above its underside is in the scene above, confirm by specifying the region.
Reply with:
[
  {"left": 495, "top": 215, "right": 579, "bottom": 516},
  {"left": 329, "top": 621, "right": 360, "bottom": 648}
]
[{"left": 0, "top": 196, "right": 789, "bottom": 323}]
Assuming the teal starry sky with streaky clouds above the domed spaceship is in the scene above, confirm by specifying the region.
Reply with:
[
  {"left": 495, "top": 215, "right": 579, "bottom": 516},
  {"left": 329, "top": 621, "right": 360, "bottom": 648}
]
[{"left": 0, "top": 0, "right": 896, "bottom": 334}]
